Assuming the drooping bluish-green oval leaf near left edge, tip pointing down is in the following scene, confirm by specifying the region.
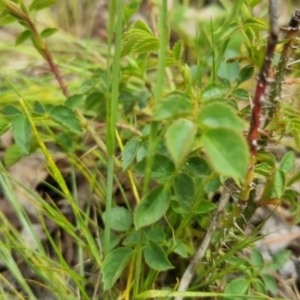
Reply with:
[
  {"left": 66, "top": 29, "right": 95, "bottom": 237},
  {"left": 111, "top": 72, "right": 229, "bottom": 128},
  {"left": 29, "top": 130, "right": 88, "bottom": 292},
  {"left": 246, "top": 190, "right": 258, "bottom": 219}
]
[{"left": 12, "top": 115, "right": 31, "bottom": 153}]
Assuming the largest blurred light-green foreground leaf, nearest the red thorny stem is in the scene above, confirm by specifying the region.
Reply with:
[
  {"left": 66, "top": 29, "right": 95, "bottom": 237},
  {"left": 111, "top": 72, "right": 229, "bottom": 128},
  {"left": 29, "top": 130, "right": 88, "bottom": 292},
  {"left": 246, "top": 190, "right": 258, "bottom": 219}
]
[{"left": 201, "top": 128, "right": 249, "bottom": 179}]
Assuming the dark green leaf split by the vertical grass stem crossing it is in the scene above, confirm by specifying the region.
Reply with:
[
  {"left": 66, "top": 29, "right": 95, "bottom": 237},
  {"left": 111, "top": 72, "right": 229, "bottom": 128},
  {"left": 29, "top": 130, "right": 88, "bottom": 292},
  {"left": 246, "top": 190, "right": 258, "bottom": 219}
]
[{"left": 135, "top": 154, "right": 175, "bottom": 179}]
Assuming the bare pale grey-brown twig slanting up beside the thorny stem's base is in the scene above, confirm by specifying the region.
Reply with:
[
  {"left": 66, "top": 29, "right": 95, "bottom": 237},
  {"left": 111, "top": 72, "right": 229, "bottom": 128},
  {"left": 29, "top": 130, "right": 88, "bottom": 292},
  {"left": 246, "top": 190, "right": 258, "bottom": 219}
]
[{"left": 175, "top": 187, "right": 230, "bottom": 300}]
